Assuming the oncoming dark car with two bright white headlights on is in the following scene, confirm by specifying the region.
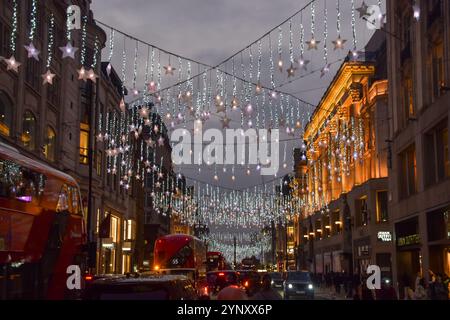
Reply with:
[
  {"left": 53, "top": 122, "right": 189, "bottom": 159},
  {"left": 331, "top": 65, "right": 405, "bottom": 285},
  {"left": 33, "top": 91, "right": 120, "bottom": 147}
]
[{"left": 283, "top": 271, "right": 314, "bottom": 300}]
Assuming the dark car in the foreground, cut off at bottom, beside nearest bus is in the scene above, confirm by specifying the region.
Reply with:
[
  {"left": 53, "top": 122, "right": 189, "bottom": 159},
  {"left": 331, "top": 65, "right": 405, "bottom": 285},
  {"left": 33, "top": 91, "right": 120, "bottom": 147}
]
[{"left": 83, "top": 274, "right": 198, "bottom": 300}]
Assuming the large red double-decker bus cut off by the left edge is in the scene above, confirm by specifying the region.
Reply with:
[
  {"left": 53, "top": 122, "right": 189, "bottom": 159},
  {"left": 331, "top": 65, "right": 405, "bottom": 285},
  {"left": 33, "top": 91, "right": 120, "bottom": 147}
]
[{"left": 0, "top": 143, "right": 86, "bottom": 299}]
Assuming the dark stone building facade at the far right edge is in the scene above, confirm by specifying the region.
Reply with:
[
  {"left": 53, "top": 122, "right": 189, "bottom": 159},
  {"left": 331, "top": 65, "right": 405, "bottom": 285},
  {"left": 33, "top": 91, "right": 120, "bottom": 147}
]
[{"left": 387, "top": 0, "right": 450, "bottom": 294}]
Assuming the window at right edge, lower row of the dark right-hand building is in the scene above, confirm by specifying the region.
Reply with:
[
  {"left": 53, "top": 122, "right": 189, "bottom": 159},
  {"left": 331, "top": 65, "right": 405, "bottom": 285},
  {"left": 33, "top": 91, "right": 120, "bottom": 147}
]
[{"left": 424, "top": 120, "right": 450, "bottom": 186}]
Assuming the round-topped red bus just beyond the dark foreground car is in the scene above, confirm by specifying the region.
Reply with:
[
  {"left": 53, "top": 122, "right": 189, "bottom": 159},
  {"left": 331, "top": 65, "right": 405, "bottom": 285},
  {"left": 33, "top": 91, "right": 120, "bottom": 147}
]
[{"left": 153, "top": 234, "right": 206, "bottom": 273}]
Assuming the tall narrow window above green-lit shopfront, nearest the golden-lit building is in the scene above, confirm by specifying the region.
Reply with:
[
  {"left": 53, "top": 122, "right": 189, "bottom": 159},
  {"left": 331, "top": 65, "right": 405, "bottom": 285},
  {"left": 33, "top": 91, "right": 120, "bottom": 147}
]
[{"left": 399, "top": 144, "right": 417, "bottom": 199}]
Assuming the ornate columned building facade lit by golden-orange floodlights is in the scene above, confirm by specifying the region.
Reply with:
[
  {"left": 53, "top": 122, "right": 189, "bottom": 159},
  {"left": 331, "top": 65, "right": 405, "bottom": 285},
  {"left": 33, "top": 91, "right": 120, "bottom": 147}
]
[{"left": 294, "top": 33, "right": 393, "bottom": 277}]
